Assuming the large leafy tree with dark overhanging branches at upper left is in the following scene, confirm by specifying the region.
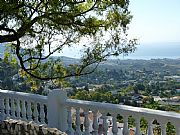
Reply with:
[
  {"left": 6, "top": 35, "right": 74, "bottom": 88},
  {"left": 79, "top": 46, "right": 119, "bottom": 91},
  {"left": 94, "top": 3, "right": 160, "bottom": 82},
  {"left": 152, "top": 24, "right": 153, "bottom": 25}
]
[{"left": 0, "top": 0, "right": 136, "bottom": 80}]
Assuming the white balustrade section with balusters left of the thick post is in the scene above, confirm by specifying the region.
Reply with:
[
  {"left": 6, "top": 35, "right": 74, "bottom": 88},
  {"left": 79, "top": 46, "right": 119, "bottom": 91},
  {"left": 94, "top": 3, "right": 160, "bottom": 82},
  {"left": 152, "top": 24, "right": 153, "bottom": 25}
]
[{"left": 0, "top": 90, "right": 47, "bottom": 124}]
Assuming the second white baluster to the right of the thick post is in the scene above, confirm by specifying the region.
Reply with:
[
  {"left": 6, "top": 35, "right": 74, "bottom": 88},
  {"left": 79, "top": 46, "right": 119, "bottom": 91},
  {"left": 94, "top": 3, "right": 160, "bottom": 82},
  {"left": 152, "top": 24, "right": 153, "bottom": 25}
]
[{"left": 74, "top": 108, "right": 82, "bottom": 135}]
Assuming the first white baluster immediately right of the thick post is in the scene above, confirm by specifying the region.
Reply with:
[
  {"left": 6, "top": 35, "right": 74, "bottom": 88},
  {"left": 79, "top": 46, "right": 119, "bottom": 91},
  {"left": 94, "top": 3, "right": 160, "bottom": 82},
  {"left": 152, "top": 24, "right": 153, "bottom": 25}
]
[{"left": 66, "top": 107, "right": 74, "bottom": 135}]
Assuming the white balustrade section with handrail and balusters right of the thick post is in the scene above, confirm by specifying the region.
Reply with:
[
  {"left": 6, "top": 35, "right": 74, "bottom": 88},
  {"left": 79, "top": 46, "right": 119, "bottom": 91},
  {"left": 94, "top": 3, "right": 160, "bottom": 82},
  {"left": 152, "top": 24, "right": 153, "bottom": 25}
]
[{"left": 66, "top": 92, "right": 180, "bottom": 135}]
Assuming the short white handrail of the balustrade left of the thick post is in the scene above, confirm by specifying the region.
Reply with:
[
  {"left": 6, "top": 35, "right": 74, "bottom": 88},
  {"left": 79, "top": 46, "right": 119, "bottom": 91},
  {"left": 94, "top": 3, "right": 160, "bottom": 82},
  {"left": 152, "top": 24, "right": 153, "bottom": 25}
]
[{"left": 0, "top": 89, "right": 47, "bottom": 104}]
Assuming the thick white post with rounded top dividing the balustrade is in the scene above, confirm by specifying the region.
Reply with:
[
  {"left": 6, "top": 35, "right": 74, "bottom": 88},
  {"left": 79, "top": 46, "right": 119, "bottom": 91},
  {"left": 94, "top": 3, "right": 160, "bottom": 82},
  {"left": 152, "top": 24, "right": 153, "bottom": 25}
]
[{"left": 47, "top": 89, "right": 67, "bottom": 132}]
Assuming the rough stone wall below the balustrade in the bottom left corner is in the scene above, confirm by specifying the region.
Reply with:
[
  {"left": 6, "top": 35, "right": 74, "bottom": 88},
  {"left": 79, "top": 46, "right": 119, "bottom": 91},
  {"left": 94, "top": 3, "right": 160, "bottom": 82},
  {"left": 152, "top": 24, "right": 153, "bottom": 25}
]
[{"left": 0, "top": 119, "right": 67, "bottom": 135}]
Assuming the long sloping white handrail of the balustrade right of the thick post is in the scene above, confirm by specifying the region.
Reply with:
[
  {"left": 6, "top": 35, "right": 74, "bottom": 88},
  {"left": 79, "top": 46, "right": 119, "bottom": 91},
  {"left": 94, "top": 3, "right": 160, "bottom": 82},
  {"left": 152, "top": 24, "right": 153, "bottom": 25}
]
[{"left": 66, "top": 99, "right": 180, "bottom": 123}]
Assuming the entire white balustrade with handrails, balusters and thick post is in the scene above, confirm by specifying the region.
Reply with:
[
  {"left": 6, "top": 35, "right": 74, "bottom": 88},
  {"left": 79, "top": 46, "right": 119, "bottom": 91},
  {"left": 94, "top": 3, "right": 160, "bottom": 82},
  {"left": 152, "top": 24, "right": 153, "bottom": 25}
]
[{"left": 0, "top": 89, "right": 180, "bottom": 135}]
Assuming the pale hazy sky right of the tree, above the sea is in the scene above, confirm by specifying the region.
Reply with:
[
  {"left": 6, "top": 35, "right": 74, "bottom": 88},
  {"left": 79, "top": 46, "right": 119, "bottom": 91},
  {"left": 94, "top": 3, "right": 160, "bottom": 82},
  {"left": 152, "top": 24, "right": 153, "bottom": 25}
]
[{"left": 129, "top": 0, "right": 180, "bottom": 43}]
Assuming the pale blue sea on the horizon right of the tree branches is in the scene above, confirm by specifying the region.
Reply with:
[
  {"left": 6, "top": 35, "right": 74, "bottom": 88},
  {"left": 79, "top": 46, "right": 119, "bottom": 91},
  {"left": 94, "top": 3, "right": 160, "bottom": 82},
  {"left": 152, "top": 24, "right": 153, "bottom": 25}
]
[{"left": 120, "top": 42, "right": 180, "bottom": 60}]
